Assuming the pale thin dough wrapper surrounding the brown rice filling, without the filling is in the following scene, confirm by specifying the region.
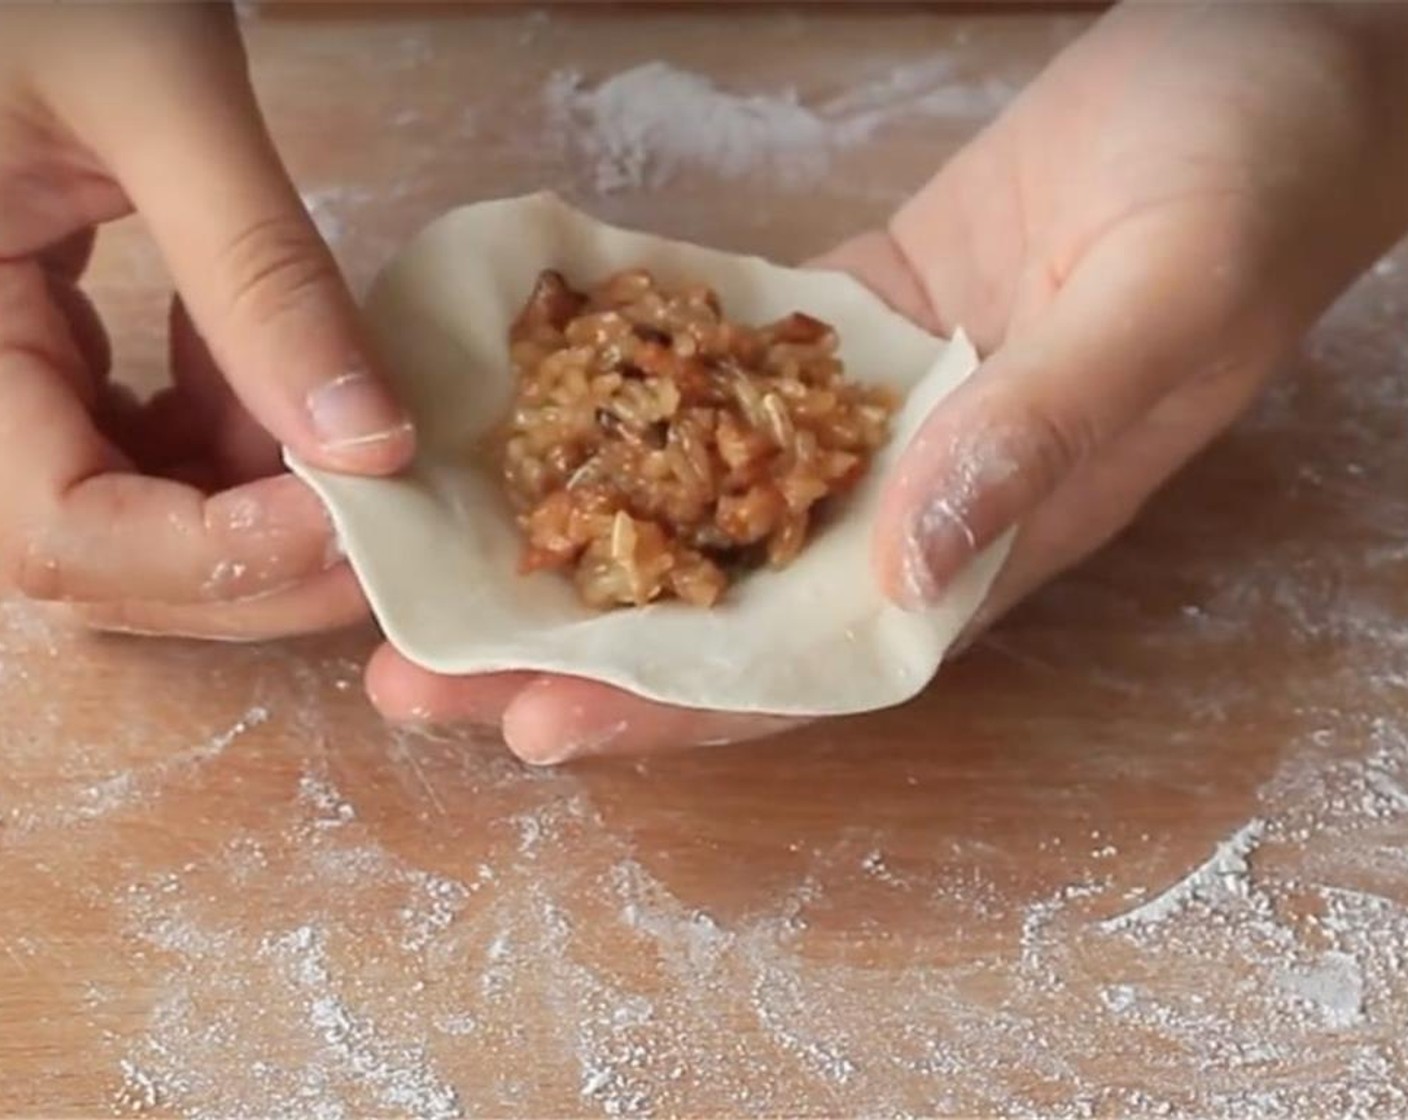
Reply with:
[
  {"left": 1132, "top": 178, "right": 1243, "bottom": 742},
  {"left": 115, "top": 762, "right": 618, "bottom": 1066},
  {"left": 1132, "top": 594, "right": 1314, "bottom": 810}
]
[{"left": 290, "top": 194, "right": 1010, "bottom": 716}]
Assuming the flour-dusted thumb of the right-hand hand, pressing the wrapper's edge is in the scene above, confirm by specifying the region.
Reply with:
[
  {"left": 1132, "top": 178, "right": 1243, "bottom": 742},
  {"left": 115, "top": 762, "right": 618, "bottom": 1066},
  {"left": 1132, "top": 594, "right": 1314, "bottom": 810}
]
[{"left": 874, "top": 205, "right": 1270, "bottom": 610}]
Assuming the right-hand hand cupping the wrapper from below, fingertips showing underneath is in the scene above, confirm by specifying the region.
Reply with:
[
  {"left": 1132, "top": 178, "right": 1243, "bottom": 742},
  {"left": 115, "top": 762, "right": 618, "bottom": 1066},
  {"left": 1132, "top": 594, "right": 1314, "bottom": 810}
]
[{"left": 367, "top": 6, "right": 1408, "bottom": 762}]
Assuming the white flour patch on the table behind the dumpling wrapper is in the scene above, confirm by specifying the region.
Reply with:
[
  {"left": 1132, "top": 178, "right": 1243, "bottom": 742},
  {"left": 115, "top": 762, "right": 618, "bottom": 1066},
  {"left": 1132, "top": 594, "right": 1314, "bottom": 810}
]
[{"left": 543, "top": 55, "right": 1015, "bottom": 193}]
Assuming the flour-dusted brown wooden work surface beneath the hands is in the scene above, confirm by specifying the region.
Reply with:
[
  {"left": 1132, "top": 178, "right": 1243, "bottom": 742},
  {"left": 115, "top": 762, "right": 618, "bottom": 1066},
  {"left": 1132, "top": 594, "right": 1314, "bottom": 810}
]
[{"left": 0, "top": 11, "right": 1408, "bottom": 1117}]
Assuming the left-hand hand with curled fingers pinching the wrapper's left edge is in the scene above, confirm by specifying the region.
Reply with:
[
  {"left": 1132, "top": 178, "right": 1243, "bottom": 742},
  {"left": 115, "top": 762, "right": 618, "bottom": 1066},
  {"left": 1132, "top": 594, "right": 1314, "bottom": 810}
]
[{"left": 0, "top": 4, "right": 414, "bottom": 638}]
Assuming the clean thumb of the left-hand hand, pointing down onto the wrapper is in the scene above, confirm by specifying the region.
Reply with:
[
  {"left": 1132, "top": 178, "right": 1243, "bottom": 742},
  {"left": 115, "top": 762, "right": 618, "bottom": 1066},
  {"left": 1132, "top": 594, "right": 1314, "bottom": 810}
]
[{"left": 70, "top": 13, "right": 415, "bottom": 475}]
